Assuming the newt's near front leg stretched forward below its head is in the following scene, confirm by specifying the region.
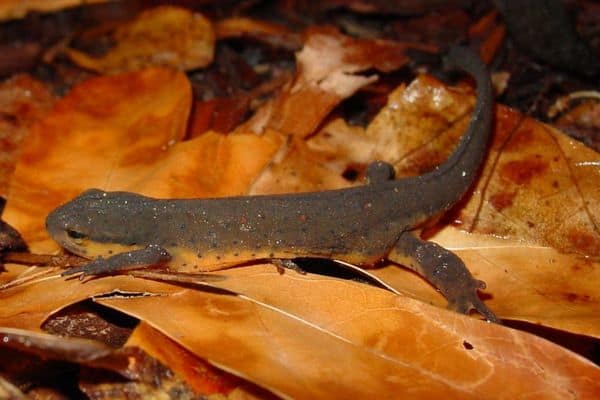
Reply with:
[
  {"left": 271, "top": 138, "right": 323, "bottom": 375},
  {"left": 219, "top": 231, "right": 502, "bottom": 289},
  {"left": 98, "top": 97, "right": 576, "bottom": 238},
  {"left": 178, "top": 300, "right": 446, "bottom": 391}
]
[{"left": 62, "top": 244, "right": 171, "bottom": 279}]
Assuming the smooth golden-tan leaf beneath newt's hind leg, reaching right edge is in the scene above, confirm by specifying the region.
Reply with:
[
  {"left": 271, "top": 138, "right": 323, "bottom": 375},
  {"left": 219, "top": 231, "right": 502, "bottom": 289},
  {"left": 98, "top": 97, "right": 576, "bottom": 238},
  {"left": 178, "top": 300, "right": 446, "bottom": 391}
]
[{"left": 370, "top": 230, "right": 600, "bottom": 338}]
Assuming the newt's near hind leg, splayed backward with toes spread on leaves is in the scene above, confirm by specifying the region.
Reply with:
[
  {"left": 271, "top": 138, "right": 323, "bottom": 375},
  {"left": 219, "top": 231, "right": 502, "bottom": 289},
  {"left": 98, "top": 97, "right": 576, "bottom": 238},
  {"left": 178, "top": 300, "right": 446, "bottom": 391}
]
[{"left": 388, "top": 232, "right": 498, "bottom": 322}]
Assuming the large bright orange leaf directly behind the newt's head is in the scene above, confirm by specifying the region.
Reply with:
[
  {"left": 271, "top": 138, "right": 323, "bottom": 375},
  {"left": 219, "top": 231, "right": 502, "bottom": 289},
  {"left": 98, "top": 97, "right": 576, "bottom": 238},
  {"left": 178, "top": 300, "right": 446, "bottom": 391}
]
[{"left": 4, "top": 69, "right": 191, "bottom": 252}]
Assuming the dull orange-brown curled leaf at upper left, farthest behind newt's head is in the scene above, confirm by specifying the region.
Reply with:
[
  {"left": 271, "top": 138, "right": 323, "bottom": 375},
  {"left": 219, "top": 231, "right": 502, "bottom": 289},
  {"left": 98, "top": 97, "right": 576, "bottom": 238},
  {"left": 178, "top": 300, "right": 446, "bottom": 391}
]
[{"left": 66, "top": 6, "right": 215, "bottom": 74}]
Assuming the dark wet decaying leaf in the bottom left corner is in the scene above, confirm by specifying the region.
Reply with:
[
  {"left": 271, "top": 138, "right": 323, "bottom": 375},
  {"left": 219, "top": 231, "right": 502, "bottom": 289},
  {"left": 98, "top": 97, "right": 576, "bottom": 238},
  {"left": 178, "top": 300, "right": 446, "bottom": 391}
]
[{"left": 0, "top": 328, "right": 206, "bottom": 399}]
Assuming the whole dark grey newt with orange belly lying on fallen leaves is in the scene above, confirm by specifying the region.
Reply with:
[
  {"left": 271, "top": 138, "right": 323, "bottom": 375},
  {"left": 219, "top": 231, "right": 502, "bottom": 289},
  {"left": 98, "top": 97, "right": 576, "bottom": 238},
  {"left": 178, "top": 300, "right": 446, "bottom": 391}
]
[{"left": 46, "top": 48, "right": 497, "bottom": 322}]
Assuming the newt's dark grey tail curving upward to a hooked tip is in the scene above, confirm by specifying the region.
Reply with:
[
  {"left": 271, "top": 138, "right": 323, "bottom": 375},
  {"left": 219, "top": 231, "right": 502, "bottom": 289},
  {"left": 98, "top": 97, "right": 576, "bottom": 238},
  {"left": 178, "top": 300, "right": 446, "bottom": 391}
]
[{"left": 409, "top": 47, "right": 493, "bottom": 216}]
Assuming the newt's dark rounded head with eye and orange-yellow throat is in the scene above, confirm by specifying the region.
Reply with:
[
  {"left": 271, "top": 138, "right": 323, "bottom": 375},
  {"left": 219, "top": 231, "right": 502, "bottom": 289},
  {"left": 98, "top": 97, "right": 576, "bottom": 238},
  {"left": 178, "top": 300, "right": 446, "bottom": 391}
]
[{"left": 46, "top": 189, "right": 150, "bottom": 258}]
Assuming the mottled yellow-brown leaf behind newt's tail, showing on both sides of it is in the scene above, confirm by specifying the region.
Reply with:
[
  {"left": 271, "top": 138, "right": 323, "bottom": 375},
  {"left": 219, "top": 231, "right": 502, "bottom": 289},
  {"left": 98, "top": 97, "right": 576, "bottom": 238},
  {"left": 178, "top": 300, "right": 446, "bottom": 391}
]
[{"left": 366, "top": 78, "right": 600, "bottom": 257}]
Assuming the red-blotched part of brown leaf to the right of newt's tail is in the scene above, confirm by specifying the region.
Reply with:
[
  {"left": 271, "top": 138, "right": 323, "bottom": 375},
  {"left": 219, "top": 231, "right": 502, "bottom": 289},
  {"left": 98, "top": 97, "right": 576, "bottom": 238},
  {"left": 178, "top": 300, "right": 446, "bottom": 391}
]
[{"left": 459, "top": 107, "right": 600, "bottom": 259}]
